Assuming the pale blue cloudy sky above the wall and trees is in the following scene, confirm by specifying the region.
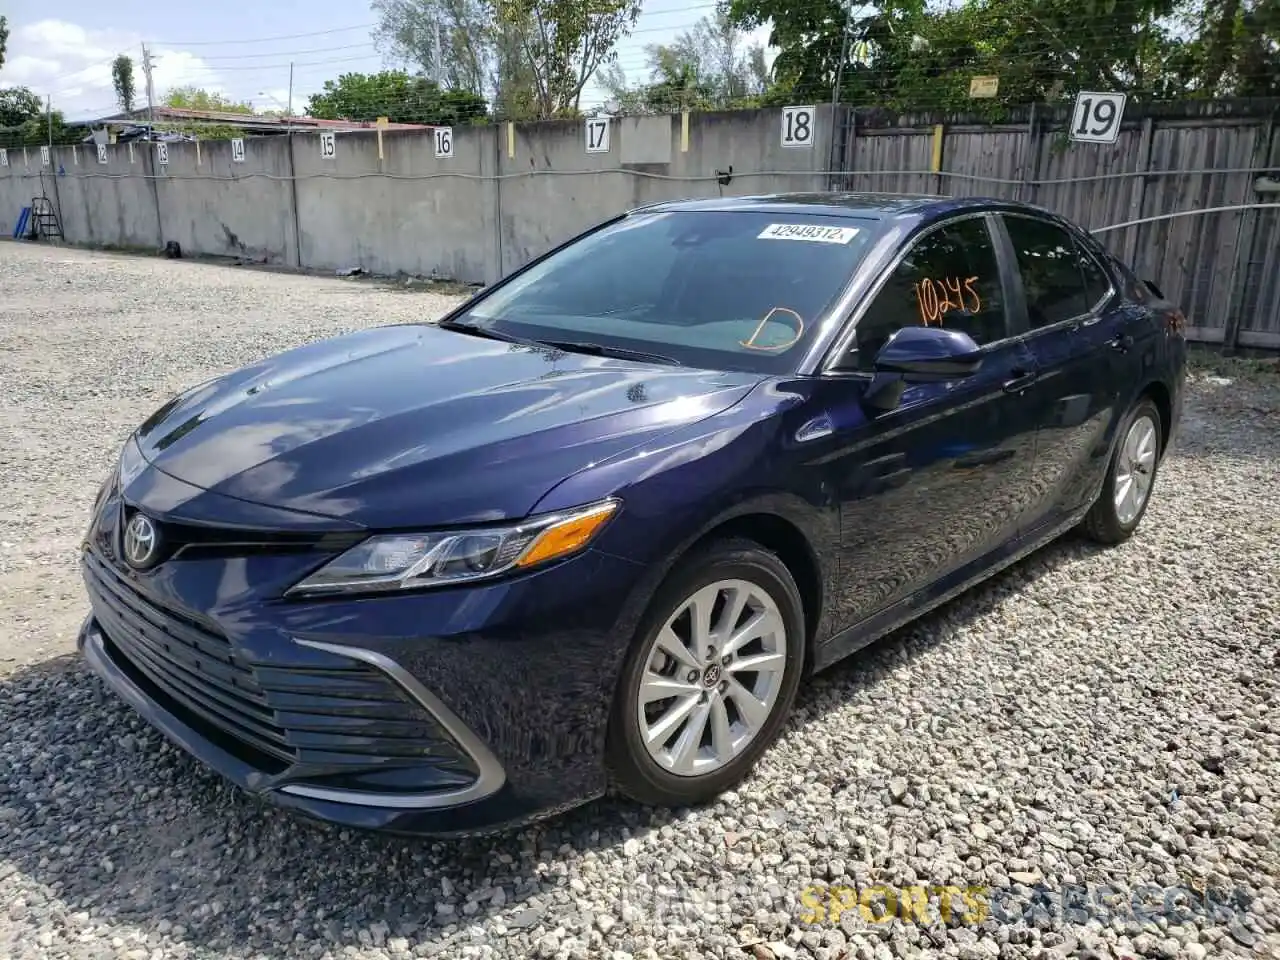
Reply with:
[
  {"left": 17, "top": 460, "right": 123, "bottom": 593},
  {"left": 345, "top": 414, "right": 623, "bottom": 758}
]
[{"left": 0, "top": 0, "right": 767, "bottom": 120}]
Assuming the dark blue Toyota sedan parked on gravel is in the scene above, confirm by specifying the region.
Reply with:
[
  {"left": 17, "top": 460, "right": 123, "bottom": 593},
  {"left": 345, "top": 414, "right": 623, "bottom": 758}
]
[{"left": 79, "top": 195, "right": 1187, "bottom": 835}]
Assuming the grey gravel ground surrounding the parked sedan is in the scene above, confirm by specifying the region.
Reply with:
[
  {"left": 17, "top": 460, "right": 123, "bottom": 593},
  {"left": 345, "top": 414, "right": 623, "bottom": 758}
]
[{"left": 0, "top": 243, "right": 1280, "bottom": 960}]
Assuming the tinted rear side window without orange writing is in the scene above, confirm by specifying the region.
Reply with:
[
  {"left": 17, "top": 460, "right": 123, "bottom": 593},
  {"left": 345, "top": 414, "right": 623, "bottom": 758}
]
[{"left": 1005, "top": 216, "right": 1105, "bottom": 330}]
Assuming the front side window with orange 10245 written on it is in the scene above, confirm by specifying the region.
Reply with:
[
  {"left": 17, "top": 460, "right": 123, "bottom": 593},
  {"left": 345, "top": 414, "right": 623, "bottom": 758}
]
[{"left": 855, "top": 218, "right": 1007, "bottom": 371}]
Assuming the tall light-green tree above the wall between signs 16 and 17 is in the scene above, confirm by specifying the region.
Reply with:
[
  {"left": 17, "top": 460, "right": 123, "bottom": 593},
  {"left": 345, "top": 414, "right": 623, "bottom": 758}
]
[{"left": 497, "top": 0, "right": 640, "bottom": 119}]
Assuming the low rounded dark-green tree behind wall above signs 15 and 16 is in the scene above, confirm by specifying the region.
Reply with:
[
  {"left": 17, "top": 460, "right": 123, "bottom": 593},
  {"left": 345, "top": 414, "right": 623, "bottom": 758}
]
[{"left": 307, "top": 70, "right": 489, "bottom": 125}]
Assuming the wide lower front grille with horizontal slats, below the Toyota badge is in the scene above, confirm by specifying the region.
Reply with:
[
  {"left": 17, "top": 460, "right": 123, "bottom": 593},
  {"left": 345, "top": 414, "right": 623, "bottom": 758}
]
[{"left": 83, "top": 550, "right": 476, "bottom": 788}]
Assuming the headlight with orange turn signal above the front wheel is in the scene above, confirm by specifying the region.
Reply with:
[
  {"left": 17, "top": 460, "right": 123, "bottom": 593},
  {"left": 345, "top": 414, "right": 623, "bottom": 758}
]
[{"left": 288, "top": 499, "right": 618, "bottom": 596}]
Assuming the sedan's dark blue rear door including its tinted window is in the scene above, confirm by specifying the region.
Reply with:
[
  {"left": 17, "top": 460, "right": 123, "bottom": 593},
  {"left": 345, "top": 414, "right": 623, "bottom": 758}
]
[{"left": 1000, "top": 212, "right": 1132, "bottom": 530}]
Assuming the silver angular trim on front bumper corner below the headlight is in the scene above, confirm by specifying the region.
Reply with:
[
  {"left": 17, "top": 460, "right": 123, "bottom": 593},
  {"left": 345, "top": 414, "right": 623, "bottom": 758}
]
[{"left": 280, "top": 637, "right": 507, "bottom": 810}]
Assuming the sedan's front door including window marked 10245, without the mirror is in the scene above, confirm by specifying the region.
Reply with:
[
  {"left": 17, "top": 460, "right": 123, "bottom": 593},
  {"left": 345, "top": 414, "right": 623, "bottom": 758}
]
[{"left": 828, "top": 215, "right": 1037, "bottom": 627}]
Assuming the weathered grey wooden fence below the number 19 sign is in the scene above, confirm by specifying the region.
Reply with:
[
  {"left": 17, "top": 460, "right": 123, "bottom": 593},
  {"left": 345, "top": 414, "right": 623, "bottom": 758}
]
[{"left": 832, "top": 100, "right": 1280, "bottom": 348}]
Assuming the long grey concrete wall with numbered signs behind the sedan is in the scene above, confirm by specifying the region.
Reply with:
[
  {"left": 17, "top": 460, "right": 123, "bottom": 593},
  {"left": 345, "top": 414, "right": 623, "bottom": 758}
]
[{"left": 0, "top": 106, "right": 832, "bottom": 283}]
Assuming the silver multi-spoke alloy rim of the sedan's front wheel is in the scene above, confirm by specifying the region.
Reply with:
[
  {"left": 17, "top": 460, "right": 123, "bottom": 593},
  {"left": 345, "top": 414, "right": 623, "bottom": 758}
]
[{"left": 636, "top": 580, "right": 790, "bottom": 777}]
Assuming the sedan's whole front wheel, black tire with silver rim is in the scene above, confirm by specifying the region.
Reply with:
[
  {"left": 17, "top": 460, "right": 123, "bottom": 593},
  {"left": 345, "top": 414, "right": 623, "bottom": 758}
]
[{"left": 607, "top": 538, "right": 805, "bottom": 806}]
